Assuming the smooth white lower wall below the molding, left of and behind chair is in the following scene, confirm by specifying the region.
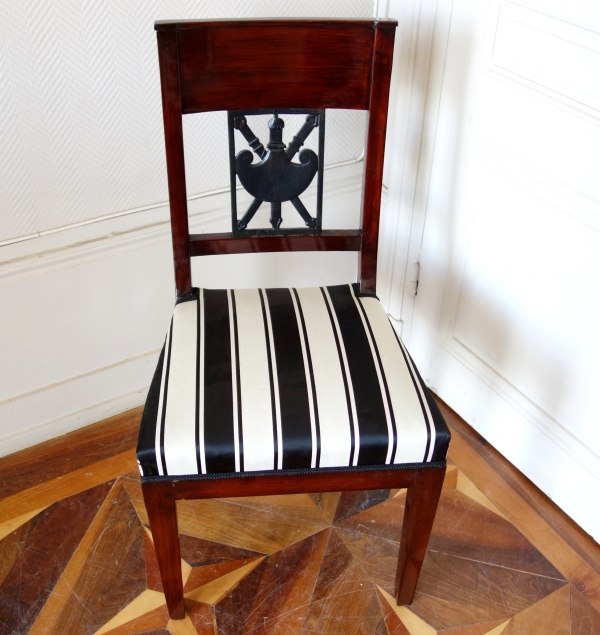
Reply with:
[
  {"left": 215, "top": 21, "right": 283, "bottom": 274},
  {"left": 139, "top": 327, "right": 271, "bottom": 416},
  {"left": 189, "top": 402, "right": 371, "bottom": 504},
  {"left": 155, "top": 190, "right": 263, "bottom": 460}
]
[{"left": 0, "top": 162, "right": 362, "bottom": 456}]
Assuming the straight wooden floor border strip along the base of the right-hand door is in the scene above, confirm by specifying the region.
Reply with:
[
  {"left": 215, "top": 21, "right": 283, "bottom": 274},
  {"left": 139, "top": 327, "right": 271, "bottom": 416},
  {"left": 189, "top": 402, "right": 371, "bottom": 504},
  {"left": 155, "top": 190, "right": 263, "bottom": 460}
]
[{"left": 435, "top": 397, "right": 600, "bottom": 573}]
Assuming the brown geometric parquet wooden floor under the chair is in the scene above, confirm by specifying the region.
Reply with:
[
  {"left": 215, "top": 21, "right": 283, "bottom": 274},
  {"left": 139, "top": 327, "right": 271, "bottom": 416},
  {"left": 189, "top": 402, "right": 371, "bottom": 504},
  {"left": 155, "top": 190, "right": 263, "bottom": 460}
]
[{"left": 0, "top": 404, "right": 600, "bottom": 635}]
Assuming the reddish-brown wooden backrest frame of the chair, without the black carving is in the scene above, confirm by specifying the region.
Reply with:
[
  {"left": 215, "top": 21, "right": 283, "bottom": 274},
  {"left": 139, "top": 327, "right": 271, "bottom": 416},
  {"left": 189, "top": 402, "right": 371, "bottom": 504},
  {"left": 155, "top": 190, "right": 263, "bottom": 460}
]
[{"left": 155, "top": 19, "right": 397, "bottom": 297}]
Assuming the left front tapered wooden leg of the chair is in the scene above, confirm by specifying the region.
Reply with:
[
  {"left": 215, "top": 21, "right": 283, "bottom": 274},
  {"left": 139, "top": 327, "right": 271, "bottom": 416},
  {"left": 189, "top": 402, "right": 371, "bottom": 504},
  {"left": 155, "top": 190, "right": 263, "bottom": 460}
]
[{"left": 142, "top": 483, "right": 185, "bottom": 620}]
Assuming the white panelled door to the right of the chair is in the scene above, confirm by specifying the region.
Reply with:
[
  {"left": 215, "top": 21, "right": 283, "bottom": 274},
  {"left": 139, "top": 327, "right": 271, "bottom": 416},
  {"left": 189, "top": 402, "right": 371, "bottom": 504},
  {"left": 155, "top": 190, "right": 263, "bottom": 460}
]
[{"left": 407, "top": 0, "right": 600, "bottom": 540}]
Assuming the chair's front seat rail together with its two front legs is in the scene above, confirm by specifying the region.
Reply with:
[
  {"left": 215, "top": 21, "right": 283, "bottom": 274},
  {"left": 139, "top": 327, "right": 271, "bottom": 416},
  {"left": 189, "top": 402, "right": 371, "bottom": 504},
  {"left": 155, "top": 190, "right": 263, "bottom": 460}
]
[{"left": 142, "top": 465, "right": 446, "bottom": 619}]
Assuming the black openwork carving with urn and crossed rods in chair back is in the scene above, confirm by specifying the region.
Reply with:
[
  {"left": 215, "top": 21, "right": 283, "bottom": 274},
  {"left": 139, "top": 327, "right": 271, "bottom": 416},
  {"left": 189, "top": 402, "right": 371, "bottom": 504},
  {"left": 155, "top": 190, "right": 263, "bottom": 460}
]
[{"left": 229, "top": 110, "right": 325, "bottom": 235}]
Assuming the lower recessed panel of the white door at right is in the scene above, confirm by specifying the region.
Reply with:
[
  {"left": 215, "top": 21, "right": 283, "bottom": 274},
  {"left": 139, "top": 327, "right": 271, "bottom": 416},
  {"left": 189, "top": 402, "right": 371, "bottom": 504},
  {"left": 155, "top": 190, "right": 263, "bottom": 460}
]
[{"left": 445, "top": 160, "right": 600, "bottom": 479}]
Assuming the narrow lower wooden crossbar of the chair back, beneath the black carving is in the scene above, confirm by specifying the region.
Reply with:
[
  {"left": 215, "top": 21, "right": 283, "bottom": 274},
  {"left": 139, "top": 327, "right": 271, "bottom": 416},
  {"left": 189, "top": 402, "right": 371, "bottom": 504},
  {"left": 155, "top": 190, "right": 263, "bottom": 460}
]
[{"left": 190, "top": 230, "right": 361, "bottom": 256}]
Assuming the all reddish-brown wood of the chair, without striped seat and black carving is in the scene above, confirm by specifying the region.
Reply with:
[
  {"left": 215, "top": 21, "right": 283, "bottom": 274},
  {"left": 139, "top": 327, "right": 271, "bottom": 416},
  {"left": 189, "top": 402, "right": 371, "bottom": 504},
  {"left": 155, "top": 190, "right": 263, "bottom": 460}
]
[{"left": 142, "top": 19, "right": 446, "bottom": 619}]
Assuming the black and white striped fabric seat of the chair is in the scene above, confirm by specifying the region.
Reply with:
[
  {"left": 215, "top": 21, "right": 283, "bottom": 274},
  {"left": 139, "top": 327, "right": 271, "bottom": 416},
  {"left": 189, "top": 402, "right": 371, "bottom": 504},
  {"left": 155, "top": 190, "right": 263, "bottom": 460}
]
[{"left": 138, "top": 285, "right": 450, "bottom": 477}]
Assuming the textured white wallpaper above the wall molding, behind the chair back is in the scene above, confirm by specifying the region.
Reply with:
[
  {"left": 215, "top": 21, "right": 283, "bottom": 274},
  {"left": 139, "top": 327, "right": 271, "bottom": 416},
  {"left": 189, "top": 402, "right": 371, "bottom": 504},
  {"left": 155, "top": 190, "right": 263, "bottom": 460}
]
[{"left": 0, "top": 0, "right": 373, "bottom": 242}]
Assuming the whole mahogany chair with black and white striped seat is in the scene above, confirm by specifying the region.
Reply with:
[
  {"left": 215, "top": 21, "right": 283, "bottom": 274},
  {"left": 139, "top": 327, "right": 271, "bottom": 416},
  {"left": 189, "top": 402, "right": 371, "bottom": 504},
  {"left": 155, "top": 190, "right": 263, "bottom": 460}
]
[{"left": 137, "top": 19, "right": 450, "bottom": 619}]
